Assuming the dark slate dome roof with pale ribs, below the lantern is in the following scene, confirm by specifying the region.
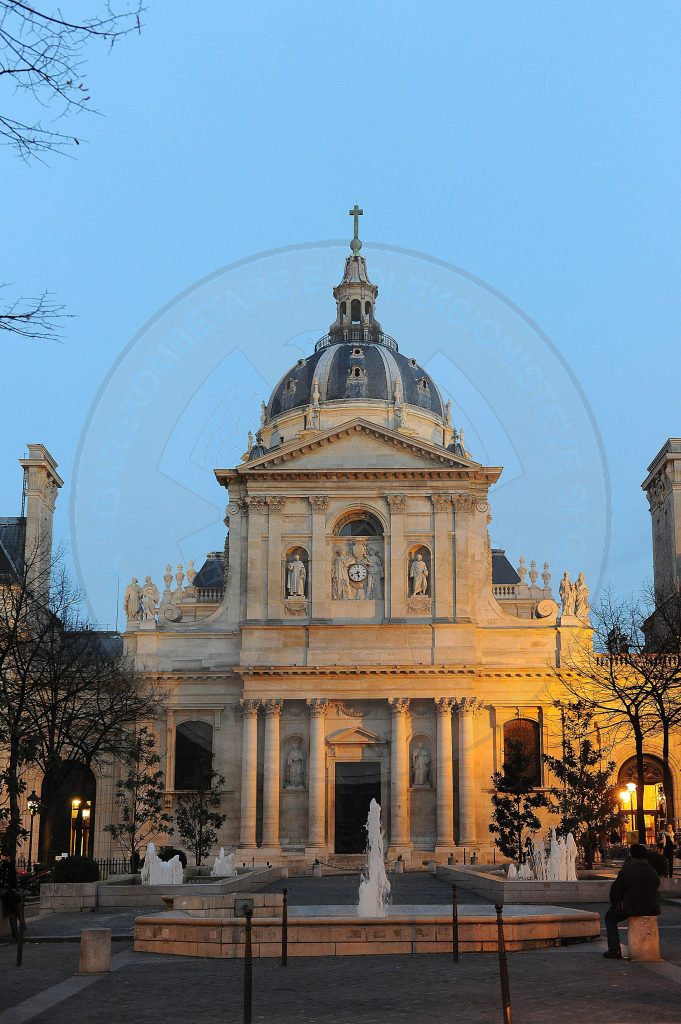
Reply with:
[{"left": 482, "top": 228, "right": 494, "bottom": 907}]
[{"left": 267, "top": 337, "right": 445, "bottom": 420}]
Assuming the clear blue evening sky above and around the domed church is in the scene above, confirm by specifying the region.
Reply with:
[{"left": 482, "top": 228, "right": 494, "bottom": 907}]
[{"left": 0, "top": 0, "right": 681, "bottom": 624}]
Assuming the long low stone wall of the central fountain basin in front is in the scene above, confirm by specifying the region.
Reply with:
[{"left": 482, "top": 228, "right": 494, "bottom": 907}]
[{"left": 134, "top": 911, "right": 600, "bottom": 958}]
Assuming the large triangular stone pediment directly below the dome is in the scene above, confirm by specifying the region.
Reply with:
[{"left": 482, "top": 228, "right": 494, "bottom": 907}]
[{"left": 233, "top": 417, "right": 480, "bottom": 476}]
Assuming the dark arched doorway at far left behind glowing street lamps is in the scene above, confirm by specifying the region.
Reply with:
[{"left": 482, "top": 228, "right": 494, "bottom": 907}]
[{"left": 39, "top": 761, "right": 97, "bottom": 863}]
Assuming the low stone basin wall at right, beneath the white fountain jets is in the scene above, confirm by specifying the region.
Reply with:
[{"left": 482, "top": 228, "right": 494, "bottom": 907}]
[{"left": 435, "top": 865, "right": 612, "bottom": 905}]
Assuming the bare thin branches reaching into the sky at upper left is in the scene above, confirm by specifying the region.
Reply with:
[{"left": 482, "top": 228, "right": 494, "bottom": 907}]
[{"left": 0, "top": 0, "right": 144, "bottom": 340}]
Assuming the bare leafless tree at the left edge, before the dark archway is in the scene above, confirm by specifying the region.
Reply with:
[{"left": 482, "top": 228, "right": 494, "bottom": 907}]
[{"left": 0, "top": 552, "right": 165, "bottom": 857}]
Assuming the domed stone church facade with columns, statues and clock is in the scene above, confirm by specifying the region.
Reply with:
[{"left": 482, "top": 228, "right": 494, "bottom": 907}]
[{"left": 118, "top": 217, "right": 614, "bottom": 863}]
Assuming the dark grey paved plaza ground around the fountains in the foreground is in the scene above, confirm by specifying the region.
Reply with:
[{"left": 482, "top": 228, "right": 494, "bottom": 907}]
[{"left": 0, "top": 874, "right": 681, "bottom": 1024}]
